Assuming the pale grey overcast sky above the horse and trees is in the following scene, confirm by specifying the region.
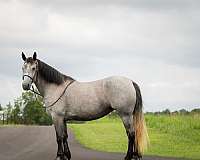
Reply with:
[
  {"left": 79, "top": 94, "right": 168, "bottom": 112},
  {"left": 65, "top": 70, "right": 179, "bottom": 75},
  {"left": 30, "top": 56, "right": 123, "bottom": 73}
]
[{"left": 0, "top": 0, "right": 200, "bottom": 111}]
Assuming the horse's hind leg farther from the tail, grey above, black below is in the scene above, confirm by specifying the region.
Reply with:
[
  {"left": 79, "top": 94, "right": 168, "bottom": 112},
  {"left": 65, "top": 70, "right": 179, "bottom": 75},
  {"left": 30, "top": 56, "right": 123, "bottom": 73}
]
[{"left": 120, "top": 113, "right": 135, "bottom": 160}]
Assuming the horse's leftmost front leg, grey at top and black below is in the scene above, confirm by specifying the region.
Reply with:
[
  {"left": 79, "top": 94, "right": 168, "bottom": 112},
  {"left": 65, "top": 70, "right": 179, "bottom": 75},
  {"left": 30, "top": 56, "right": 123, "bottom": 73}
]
[{"left": 53, "top": 117, "right": 66, "bottom": 160}]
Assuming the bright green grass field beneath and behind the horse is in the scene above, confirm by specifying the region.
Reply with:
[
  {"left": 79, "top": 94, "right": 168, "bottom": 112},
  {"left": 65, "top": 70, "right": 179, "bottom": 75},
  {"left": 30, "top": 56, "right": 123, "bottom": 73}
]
[{"left": 70, "top": 115, "right": 200, "bottom": 159}]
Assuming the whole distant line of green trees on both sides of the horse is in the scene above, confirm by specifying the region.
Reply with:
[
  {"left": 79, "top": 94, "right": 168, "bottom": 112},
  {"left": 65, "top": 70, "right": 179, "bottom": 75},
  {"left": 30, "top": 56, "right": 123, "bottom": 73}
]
[{"left": 0, "top": 92, "right": 200, "bottom": 125}]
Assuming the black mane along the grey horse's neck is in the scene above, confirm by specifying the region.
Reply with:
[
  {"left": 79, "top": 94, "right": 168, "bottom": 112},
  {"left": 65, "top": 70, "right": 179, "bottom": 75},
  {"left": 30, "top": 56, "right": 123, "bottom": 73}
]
[{"left": 37, "top": 60, "right": 74, "bottom": 85}]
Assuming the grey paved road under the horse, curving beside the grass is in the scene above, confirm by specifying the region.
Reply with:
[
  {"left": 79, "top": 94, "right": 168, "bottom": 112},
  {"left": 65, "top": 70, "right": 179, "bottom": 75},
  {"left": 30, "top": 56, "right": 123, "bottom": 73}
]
[{"left": 0, "top": 126, "right": 184, "bottom": 160}]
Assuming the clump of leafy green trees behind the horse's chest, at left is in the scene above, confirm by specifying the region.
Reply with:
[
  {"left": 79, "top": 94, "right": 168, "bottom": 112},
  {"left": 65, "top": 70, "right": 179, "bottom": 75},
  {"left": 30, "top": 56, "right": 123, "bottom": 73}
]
[{"left": 0, "top": 92, "right": 52, "bottom": 125}]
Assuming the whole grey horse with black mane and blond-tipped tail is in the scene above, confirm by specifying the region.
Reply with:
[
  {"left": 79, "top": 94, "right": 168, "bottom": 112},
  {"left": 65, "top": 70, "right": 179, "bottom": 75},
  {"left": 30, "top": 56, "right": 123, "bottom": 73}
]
[{"left": 22, "top": 52, "right": 148, "bottom": 160}]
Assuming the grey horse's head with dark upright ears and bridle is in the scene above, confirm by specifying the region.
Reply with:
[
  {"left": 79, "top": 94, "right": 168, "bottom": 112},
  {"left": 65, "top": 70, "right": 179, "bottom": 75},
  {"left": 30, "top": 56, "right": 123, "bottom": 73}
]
[{"left": 22, "top": 52, "right": 38, "bottom": 90}]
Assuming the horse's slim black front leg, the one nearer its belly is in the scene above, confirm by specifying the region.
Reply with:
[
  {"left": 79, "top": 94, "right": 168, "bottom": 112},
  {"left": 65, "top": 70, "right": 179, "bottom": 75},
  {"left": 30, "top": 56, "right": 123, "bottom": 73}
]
[{"left": 63, "top": 121, "right": 71, "bottom": 160}]
